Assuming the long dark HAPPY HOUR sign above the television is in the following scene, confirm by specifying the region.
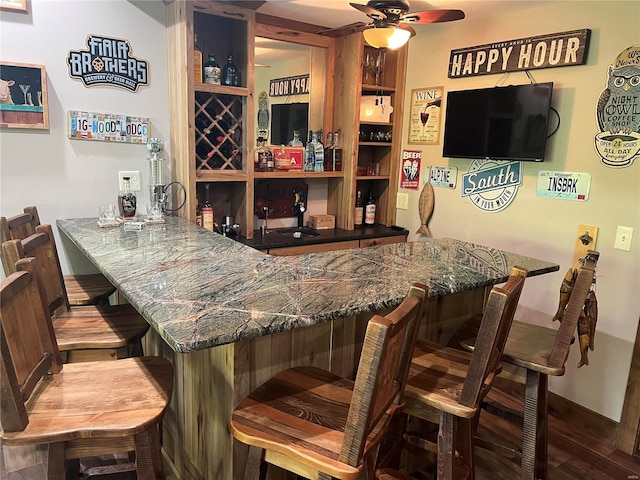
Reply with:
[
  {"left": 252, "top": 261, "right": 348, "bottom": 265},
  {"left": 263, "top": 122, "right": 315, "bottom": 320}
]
[{"left": 449, "top": 28, "right": 591, "bottom": 78}]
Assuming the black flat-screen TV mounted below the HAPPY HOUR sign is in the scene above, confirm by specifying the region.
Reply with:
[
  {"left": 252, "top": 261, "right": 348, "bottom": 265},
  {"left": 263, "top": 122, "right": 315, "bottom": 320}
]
[{"left": 442, "top": 82, "right": 553, "bottom": 162}]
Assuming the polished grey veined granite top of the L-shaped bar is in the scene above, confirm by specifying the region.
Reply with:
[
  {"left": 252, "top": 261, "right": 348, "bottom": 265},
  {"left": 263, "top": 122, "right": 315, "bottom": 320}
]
[{"left": 57, "top": 217, "right": 559, "bottom": 353}]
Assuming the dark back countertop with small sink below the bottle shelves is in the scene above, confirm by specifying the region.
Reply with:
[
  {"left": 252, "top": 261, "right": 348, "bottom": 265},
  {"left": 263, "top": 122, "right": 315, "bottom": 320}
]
[{"left": 236, "top": 225, "right": 409, "bottom": 250}]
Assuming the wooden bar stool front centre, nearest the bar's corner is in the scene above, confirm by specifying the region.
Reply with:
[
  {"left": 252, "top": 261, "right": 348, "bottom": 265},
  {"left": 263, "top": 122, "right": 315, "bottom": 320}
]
[{"left": 231, "top": 284, "right": 427, "bottom": 480}]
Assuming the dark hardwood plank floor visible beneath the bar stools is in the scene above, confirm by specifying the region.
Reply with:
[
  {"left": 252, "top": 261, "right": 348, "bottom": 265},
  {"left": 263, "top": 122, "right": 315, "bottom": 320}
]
[{"left": 0, "top": 381, "right": 640, "bottom": 480}]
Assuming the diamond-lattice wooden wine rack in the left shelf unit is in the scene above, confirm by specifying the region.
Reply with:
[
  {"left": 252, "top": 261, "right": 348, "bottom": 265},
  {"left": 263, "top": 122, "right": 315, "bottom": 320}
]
[{"left": 195, "top": 92, "right": 243, "bottom": 171}]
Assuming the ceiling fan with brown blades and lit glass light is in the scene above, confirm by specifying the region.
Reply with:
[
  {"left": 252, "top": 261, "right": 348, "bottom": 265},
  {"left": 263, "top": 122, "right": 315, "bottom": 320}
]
[{"left": 321, "top": 0, "right": 464, "bottom": 48}]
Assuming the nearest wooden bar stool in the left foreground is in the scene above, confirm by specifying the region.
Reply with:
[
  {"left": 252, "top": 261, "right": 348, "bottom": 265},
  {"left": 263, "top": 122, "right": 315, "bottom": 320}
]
[{"left": 0, "top": 258, "right": 173, "bottom": 480}]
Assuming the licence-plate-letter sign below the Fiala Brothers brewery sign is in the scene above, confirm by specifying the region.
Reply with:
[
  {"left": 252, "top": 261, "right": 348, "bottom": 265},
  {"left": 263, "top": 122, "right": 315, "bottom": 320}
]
[{"left": 67, "top": 110, "right": 149, "bottom": 143}]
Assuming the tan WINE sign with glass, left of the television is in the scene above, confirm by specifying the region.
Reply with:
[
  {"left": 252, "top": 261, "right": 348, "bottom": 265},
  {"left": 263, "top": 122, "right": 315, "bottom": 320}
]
[{"left": 409, "top": 87, "right": 444, "bottom": 145}]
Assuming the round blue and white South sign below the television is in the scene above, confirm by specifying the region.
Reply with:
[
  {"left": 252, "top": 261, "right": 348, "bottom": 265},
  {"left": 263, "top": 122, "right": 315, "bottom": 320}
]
[{"left": 461, "top": 160, "right": 522, "bottom": 212}]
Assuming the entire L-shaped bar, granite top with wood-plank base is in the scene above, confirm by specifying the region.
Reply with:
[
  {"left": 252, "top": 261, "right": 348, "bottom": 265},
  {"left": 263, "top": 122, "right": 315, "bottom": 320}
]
[{"left": 57, "top": 217, "right": 559, "bottom": 480}]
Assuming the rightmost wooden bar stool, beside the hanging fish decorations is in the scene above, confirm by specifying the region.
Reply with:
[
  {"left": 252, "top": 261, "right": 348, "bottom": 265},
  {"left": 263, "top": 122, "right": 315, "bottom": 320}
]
[{"left": 468, "top": 250, "right": 600, "bottom": 480}]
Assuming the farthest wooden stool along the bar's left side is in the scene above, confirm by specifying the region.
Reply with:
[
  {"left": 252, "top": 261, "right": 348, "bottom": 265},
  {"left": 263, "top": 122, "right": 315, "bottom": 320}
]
[{"left": 0, "top": 206, "right": 116, "bottom": 305}]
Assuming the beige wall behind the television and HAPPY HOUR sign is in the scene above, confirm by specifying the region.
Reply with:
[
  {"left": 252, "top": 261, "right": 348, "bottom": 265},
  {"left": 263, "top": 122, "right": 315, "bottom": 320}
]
[{"left": 397, "top": 1, "right": 640, "bottom": 421}]
